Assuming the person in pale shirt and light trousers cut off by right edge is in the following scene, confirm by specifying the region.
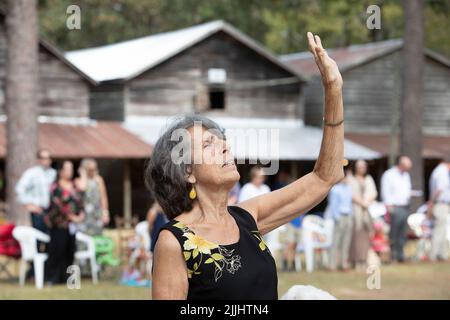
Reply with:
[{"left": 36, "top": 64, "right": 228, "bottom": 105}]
[{"left": 428, "top": 156, "right": 450, "bottom": 261}]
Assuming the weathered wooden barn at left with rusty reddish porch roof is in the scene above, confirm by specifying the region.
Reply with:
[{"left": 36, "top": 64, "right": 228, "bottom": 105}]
[{"left": 0, "top": 12, "right": 151, "bottom": 228}]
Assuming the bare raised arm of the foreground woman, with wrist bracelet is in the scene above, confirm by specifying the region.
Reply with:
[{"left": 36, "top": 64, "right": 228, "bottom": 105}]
[{"left": 239, "top": 32, "right": 344, "bottom": 234}]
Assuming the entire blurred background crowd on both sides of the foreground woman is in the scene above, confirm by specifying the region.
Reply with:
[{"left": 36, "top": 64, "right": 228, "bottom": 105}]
[{"left": 11, "top": 149, "right": 450, "bottom": 284}]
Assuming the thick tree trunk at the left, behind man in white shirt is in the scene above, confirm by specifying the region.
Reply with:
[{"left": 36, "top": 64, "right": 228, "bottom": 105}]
[{"left": 5, "top": 0, "right": 39, "bottom": 224}]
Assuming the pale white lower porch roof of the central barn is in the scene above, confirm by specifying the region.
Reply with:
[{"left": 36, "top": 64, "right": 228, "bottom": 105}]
[{"left": 124, "top": 116, "right": 380, "bottom": 160}]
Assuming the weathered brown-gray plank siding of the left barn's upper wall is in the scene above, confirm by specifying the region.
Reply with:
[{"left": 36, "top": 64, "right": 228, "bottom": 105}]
[{"left": 0, "top": 18, "right": 89, "bottom": 117}]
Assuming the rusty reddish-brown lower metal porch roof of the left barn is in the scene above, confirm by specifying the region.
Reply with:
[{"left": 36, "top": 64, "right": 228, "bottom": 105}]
[{"left": 0, "top": 122, "right": 152, "bottom": 159}]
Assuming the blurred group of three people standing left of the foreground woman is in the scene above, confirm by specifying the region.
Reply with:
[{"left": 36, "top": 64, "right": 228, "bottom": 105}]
[{"left": 16, "top": 149, "right": 110, "bottom": 285}]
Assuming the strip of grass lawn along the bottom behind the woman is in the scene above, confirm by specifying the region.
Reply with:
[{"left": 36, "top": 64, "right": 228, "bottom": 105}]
[{"left": 0, "top": 262, "right": 450, "bottom": 300}]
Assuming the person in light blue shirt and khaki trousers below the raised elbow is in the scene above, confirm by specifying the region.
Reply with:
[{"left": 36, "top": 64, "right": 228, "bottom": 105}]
[{"left": 327, "top": 169, "right": 353, "bottom": 271}]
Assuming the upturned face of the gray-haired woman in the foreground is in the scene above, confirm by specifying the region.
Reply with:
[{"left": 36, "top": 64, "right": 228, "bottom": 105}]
[{"left": 188, "top": 125, "right": 240, "bottom": 190}]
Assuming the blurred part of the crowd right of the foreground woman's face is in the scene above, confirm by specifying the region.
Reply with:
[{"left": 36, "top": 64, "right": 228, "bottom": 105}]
[{"left": 206, "top": 156, "right": 450, "bottom": 271}]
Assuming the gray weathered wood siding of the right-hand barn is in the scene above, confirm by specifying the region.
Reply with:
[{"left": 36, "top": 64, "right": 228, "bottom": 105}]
[{"left": 305, "top": 51, "right": 450, "bottom": 135}]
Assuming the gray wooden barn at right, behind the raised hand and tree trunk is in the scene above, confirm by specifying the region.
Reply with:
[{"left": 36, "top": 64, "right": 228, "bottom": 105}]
[{"left": 280, "top": 39, "right": 450, "bottom": 196}]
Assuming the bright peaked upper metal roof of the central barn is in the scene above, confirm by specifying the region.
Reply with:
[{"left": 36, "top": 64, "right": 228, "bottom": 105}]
[{"left": 66, "top": 20, "right": 305, "bottom": 81}]
